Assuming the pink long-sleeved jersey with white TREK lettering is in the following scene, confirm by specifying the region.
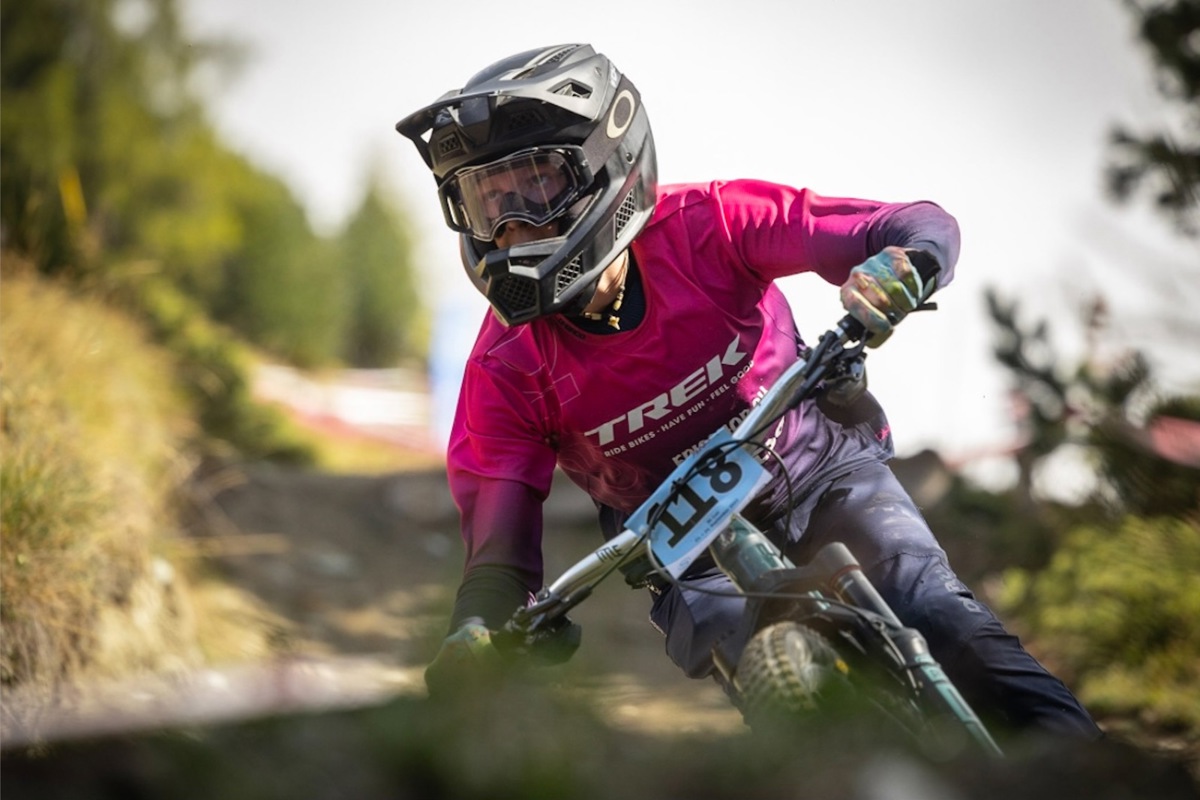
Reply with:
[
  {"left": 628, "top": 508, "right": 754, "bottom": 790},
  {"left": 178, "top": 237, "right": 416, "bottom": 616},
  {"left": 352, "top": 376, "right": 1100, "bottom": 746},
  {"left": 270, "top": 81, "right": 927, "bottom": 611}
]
[{"left": 448, "top": 181, "right": 958, "bottom": 589}]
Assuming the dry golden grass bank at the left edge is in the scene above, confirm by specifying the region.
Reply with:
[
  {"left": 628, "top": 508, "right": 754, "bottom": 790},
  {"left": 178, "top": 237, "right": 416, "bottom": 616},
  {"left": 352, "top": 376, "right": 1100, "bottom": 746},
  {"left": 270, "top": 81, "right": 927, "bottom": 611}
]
[{"left": 0, "top": 266, "right": 278, "bottom": 694}]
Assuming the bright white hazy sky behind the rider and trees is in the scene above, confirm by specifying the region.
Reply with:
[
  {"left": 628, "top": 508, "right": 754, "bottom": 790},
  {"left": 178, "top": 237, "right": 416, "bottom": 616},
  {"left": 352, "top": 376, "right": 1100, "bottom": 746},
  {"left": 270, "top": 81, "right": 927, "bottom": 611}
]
[{"left": 185, "top": 0, "right": 1200, "bottom": 491}]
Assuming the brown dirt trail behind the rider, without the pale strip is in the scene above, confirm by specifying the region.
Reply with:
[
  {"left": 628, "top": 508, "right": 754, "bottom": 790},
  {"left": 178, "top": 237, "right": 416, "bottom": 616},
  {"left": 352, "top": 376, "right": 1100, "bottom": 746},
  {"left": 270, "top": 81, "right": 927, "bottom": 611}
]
[{"left": 184, "top": 467, "right": 742, "bottom": 733}]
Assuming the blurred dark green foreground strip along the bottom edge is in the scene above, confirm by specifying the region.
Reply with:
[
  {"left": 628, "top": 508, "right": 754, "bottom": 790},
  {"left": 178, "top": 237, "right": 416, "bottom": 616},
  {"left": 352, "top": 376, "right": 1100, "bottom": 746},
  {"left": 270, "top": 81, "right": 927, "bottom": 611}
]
[{"left": 4, "top": 685, "right": 1200, "bottom": 800}]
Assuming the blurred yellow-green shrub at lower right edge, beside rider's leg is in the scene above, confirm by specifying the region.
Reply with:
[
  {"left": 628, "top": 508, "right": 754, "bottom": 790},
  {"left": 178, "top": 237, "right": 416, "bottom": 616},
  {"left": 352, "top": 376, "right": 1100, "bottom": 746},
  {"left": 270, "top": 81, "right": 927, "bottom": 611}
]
[{"left": 1001, "top": 517, "right": 1200, "bottom": 730}]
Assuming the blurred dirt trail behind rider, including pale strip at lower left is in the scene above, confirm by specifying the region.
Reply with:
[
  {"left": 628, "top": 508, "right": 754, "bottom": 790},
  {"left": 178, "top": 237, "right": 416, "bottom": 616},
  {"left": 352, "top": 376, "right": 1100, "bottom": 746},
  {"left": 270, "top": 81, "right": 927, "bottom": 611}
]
[{"left": 2, "top": 465, "right": 742, "bottom": 746}]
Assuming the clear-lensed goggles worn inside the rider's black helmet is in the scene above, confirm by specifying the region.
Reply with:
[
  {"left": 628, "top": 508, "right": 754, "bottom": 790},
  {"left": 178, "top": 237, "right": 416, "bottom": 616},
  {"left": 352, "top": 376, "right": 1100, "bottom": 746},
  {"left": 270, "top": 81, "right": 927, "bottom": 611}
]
[{"left": 438, "top": 148, "right": 592, "bottom": 241}]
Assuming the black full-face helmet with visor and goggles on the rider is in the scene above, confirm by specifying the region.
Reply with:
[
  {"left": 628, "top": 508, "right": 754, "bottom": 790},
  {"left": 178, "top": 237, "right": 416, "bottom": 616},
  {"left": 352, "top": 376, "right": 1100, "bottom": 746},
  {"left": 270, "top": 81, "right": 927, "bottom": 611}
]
[{"left": 396, "top": 44, "right": 658, "bottom": 325}]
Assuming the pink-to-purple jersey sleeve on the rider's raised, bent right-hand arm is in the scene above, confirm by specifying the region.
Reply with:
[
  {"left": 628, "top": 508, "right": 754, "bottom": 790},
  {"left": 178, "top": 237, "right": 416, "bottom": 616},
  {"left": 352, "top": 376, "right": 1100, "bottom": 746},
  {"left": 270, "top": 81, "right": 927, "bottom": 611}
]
[{"left": 713, "top": 180, "right": 959, "bottom": 285}]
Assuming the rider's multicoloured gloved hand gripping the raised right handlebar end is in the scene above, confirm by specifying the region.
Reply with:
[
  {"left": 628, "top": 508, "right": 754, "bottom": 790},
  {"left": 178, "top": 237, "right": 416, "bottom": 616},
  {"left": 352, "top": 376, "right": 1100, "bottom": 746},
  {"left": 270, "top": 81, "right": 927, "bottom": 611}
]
[{"left": 841, "top": 247, "right": 925, "bottom": 347}]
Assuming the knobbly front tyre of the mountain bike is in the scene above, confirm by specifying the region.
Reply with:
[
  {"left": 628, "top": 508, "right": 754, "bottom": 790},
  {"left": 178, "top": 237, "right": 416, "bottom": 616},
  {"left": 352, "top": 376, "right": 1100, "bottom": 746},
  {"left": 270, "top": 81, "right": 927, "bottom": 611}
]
[{"left": 734, "top": 620, "right": 848, "bottom": 728}]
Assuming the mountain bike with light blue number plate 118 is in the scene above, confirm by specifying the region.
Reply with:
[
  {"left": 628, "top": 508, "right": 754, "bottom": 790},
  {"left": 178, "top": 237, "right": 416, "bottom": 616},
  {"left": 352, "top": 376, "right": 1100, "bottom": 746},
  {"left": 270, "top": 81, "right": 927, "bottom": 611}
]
[{"left": 492, "top": 273, "right": 1001, "bottom": 756}]
